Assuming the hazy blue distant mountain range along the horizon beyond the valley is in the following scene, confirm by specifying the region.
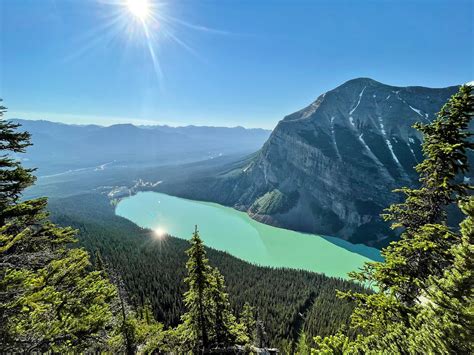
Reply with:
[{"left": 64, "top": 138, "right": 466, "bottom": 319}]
[{"left": 13, "top": 119, "right": 271, "bottom": 175}]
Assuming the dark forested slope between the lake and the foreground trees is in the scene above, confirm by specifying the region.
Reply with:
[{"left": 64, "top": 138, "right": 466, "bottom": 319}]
[{"left": 49, "top": 194, "right": 362, "bottom": 349}]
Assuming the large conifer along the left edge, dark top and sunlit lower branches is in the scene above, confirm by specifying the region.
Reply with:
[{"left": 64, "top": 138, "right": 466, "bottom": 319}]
[{"left": 0, "top": 103, "right": 115, "bottom": 352}]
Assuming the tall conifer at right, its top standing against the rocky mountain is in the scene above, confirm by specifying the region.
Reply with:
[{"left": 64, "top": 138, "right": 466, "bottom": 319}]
[{"left": 374, "top": 85, "right": 474, "bottom": 306}]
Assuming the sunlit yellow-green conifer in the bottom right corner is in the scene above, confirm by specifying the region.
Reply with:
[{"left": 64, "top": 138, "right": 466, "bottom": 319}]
[{"left": 410, "top": 197, "right": 474, "bottom": 354}]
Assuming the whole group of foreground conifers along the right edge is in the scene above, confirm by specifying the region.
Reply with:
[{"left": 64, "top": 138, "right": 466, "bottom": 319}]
[{"left": 313, "top": 86, "right": 474, "bottom": 354}]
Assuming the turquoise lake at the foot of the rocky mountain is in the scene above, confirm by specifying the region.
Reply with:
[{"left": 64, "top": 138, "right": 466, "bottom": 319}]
[{"left": 115, "top": 192, "right": 381, "bottom": 278}]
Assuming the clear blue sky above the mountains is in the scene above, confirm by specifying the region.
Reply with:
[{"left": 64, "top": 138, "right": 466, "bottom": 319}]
[{"left": 0, "top": 0, "right": 474, "bottom": 128}]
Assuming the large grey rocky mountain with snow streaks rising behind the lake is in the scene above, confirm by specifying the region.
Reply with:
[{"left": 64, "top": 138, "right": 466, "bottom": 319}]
[{"left": 159, "top": 78, "right": 466, "bottom": 245}]
